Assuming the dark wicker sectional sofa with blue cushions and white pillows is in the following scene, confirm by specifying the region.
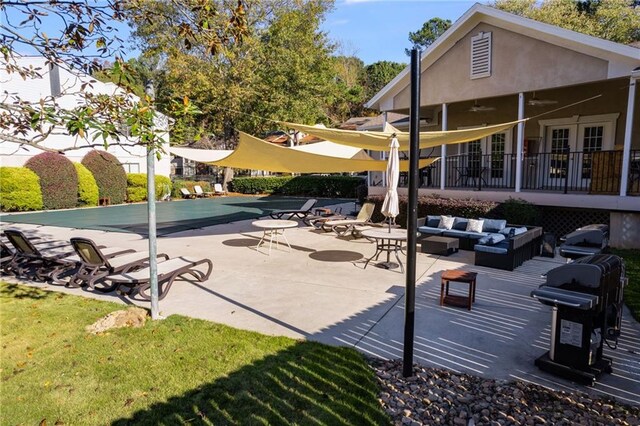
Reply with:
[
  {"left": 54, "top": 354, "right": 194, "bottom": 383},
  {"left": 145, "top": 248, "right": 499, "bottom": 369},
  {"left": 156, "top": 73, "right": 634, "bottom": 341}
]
[{"left": 418, "top": 216, "right": 542, "bottom": 271}]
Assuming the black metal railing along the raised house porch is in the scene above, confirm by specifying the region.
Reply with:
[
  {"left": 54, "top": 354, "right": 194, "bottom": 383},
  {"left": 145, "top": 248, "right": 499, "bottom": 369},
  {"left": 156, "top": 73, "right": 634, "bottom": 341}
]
[{"left": 400, "top": 150, "right": 640, "bottom": 195}]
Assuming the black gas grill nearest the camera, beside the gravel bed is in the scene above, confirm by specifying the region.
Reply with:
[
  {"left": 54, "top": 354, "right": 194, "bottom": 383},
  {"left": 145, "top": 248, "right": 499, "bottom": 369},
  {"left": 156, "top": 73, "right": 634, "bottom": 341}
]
[{"left": 531, "top": 254, "right": 626, "bottom": 385}]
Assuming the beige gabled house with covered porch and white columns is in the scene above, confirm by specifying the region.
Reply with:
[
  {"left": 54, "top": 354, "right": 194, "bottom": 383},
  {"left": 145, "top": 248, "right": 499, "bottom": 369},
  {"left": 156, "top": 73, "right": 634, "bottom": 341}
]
[{"left": 365, "top": 4, "right": 640, "bottom": 247}]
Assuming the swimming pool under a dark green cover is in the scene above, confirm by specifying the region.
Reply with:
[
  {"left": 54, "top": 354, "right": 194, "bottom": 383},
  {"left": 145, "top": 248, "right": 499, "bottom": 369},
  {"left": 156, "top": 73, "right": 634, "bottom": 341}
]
[{"left": 2, "top": 196, "right": 353, "bottom": 236}]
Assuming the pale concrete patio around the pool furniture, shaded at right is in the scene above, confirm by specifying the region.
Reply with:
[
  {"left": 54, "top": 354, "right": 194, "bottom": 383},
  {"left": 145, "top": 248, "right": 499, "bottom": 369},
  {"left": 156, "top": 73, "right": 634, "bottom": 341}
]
[{"left": 2, "top": 204, "right": 640, "bottom": 405}]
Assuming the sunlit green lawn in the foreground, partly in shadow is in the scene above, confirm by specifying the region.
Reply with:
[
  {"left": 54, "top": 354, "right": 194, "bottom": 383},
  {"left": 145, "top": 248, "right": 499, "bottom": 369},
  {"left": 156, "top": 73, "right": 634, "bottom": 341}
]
[{"left": 0, "top": 283, "right": 389, "bottom": 425}]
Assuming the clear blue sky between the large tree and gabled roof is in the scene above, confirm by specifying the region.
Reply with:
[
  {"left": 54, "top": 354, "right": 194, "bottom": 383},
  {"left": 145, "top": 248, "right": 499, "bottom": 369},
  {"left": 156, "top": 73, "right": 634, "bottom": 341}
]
[{"left": 322, "top": 0, "right": 477, "bottom": 65}]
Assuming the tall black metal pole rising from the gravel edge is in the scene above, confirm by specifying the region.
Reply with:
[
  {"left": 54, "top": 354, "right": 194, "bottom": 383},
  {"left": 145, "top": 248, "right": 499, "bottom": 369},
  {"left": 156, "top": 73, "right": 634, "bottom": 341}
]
[{"left": 402, "top": 48, "right": 420, "bottom": 377}]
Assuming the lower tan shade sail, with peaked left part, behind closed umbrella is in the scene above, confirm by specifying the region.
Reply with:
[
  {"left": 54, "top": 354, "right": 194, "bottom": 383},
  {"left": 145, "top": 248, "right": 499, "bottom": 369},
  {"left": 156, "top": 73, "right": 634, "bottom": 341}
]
[{"left": 171, "top": 132, "right": 437, "bottom": 173}]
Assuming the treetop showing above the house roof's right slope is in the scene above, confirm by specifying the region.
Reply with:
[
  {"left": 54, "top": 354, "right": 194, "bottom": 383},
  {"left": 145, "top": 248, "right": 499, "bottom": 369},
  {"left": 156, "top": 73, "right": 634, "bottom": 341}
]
[{"left": 493, "top": 0, "right": 640, "bottom": 44}]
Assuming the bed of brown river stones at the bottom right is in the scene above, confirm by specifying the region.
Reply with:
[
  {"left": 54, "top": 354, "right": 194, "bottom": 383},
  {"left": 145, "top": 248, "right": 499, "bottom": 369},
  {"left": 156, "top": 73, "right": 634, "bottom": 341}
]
[{"left": 369, "top": 359, "right": 640, "bottom": 426}]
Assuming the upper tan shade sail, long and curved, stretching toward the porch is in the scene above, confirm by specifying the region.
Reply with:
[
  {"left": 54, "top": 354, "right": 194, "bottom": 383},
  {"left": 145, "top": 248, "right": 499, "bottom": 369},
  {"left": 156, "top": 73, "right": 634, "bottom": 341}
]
[{"left": 278, "top": 119, "right": 526, "bottom": 151}]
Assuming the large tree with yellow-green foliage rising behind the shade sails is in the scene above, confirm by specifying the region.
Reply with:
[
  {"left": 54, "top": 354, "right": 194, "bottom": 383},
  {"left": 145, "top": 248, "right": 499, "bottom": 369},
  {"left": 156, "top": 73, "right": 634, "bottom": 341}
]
[{"left": 134, "top": 0, "right": 336, "bottom": 148}]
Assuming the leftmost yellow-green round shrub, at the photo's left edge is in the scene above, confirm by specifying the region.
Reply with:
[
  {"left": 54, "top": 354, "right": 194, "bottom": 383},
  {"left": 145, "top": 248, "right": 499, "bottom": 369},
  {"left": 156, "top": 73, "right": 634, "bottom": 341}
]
[{"left": 0, "top": 167, "right": 42, "bottom": 212}]
